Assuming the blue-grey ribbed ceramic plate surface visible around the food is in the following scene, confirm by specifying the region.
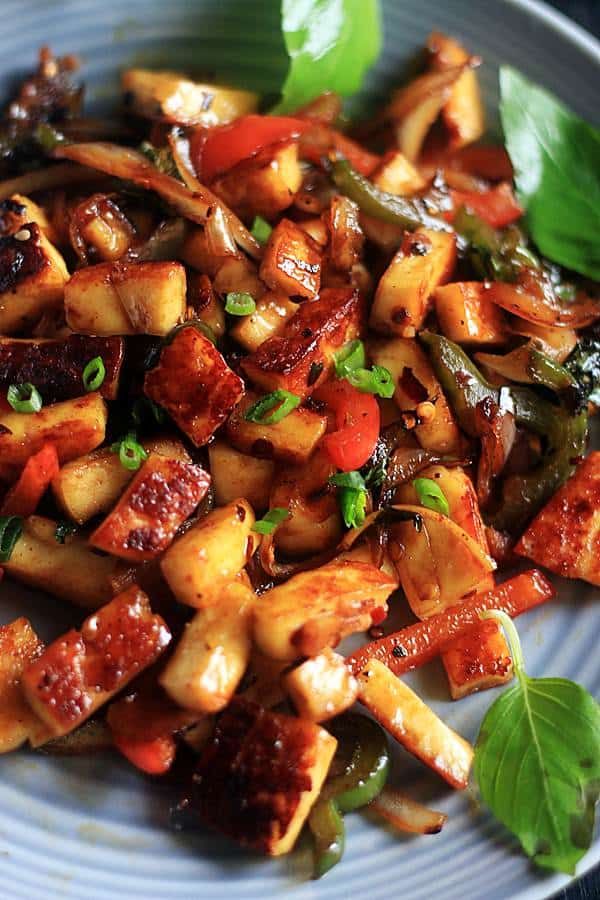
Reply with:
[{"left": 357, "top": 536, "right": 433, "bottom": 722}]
[{"left": 0, "top": 0, "right": 600, "bottom": 900}]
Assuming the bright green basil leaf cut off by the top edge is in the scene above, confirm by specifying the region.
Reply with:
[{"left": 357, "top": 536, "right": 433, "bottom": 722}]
[{"left": 276, "top": 0, "right": 381, "bottom": 113}]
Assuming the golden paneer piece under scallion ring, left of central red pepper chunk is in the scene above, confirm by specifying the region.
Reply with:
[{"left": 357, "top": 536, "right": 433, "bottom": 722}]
[{"left": 227, "top": 393, "right": 327, "bottom": 465}]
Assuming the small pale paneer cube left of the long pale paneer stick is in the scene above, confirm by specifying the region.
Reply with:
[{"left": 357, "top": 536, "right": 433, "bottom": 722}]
[{"left": 283, "top": 647, "right": 358, "bottom": 722}]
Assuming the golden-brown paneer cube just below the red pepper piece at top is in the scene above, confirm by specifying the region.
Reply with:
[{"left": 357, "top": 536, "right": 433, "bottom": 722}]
[{"left": 211, "top": 143, "right": 302, "bottom": 219}]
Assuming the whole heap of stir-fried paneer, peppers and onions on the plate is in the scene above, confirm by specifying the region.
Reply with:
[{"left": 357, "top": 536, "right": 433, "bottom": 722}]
[{"left": 0, "top": 26, "right": 600, "bottom": 875}]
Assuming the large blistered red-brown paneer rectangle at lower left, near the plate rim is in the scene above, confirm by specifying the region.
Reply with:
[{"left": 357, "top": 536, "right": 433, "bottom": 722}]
[{"left": 22, "top": 585, "right": 171, "bottom": 736}]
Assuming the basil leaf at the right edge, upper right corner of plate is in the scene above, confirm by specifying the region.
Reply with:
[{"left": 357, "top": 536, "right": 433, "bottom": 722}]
[{"left": 500, "top": 66, "right": 600, "bottom": 280}]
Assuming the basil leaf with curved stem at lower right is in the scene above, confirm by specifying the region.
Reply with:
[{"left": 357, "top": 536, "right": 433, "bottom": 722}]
[{"left": 474, "top": 610, "right": 600, "bottom": 875}]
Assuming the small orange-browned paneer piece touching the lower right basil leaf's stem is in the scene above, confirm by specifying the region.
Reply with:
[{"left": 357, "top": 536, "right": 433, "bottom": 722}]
[{"left": 442, "top": 620, "right": 513, "bottom": 700}]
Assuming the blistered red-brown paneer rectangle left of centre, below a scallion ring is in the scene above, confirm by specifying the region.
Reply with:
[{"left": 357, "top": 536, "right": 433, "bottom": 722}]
[{"left": 90, "top": 453, "right": 210, "bottom": 562}]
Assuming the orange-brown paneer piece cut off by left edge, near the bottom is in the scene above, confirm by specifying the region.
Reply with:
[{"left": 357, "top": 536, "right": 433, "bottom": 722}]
[{"left": 0, "top": 617, "right": 44, "bottom": 753}]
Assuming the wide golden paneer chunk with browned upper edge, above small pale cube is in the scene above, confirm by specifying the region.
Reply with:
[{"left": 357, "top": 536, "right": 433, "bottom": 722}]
[{"left": 254, "top": 561, "right": 398, "bottom": 660}]
